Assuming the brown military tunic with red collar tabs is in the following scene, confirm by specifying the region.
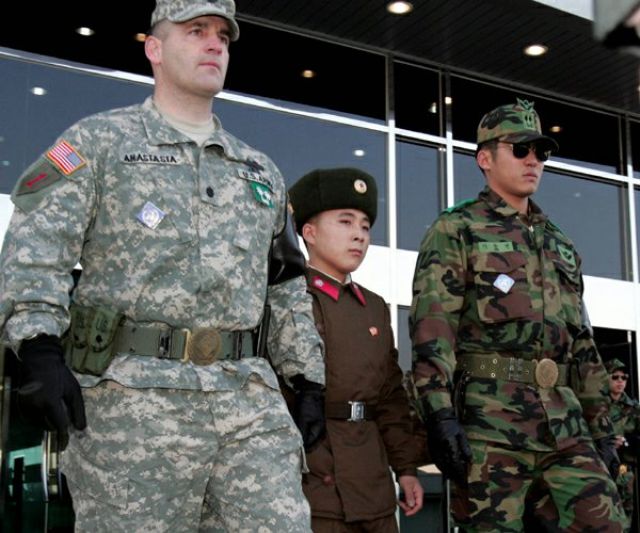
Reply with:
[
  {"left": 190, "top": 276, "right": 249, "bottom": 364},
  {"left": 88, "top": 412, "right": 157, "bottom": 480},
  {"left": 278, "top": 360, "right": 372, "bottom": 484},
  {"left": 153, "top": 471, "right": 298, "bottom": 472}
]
[{"left": 303, "top": 268, "right": 418, "bottom": 522}]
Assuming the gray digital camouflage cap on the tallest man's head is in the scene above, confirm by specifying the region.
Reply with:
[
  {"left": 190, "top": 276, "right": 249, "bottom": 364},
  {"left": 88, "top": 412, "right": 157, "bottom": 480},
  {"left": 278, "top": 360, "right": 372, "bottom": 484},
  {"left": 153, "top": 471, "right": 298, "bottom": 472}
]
[{"left": 151, "top": 0, "right": 240, "bottom": 41}]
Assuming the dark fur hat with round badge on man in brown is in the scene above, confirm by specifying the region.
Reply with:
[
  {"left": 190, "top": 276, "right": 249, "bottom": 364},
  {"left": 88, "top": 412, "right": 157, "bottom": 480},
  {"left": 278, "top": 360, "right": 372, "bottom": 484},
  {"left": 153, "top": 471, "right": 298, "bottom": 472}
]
[{"left": 289, "top": 168, "right": 378, "bottom": 235}]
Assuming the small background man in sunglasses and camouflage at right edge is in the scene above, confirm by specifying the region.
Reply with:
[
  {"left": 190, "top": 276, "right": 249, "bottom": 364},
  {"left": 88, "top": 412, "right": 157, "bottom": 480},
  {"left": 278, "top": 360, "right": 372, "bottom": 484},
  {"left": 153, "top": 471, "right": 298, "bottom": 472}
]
[{"left": 605, "top": 359, "right": 640, "bottom": 528}]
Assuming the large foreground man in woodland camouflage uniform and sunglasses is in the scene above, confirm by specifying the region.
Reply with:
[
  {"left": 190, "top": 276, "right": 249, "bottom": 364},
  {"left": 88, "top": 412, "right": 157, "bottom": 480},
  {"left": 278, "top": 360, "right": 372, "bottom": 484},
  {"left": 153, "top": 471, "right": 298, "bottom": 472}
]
[{"left": 410, "top": 99, "right": 625, "bottom": 532}]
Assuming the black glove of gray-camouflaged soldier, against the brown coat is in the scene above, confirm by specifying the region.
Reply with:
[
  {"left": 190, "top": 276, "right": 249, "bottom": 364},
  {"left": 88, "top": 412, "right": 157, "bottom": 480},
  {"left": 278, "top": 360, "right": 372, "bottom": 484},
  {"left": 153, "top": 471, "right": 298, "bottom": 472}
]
[{"left": 291, "top": 374, "right": 326, "bottom": 451}]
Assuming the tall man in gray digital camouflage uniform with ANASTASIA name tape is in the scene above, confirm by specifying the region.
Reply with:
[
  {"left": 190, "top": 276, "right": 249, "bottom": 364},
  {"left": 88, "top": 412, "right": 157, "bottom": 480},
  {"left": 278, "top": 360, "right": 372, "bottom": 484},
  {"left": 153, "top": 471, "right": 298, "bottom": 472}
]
[{"left": 0, "top": 0, "right": 324, "bottom": 533}]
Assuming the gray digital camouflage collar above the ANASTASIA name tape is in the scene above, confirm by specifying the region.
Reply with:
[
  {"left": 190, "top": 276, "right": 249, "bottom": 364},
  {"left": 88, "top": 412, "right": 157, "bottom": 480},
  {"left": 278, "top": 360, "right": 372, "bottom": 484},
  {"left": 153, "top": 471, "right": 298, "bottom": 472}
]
[{"left": 142, "top": 96, "right": 246, "bottom": 161}]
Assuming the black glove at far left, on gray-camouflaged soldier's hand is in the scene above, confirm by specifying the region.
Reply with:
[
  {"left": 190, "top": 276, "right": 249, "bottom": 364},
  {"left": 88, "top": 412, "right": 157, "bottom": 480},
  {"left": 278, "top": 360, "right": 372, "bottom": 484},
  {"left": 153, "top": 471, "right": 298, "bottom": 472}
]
[{"left": 18, "top": 335, "right": 87, "bottom": 434}]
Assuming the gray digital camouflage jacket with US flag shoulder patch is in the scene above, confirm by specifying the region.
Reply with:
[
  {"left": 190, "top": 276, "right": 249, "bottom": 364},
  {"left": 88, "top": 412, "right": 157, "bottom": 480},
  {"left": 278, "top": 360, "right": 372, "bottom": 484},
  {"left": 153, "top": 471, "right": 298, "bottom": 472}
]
[{"left": 0, "top": 98, "right": 324, "bottom": 390}]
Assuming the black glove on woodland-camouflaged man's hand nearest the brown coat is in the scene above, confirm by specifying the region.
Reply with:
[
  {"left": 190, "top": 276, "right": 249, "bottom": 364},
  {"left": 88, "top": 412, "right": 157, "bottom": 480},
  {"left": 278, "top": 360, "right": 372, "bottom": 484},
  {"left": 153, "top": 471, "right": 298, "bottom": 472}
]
[{"left": 426, "top": 408, "right": 471, "bottom": 485}]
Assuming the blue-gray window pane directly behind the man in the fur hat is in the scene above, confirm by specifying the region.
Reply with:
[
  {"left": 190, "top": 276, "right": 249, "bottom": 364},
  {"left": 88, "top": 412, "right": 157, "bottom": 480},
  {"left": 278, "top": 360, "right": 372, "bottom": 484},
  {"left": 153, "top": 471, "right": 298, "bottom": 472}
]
[{"left": 214, "top": 100, "right": 388, "bottom": 245}]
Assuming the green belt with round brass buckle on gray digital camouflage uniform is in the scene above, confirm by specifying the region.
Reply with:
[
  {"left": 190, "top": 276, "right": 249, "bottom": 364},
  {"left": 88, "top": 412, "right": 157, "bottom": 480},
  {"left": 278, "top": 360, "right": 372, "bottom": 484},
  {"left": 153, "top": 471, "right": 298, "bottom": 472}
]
[{"left": 114, "top": 325, "right": 256, "bottom": 365}]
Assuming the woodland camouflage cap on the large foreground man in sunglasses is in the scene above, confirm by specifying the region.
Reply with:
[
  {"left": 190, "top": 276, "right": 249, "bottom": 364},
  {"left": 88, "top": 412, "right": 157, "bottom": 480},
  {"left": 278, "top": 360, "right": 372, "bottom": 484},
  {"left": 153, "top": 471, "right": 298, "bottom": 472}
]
[{"left": 477, "top": 98, "right": 558, "bottom": 151}]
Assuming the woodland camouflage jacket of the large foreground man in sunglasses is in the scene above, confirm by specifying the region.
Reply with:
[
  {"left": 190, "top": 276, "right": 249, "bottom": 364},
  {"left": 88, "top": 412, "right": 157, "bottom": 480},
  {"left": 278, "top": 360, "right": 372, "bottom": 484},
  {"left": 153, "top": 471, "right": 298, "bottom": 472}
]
[{"left": 410, "top": 188, "right": 612, "bottom": 451}]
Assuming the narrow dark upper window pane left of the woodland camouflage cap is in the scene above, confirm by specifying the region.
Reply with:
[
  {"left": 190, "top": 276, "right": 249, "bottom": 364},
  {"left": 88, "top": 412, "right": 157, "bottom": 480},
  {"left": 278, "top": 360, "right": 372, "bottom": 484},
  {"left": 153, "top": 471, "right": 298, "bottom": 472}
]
[{"left": 393, "top": 63, "right": 442, "bottom": 135}]
